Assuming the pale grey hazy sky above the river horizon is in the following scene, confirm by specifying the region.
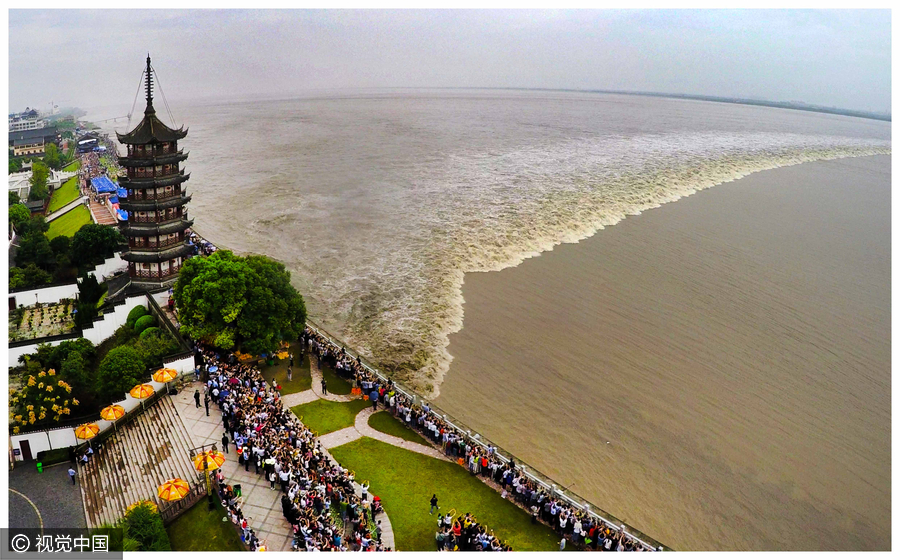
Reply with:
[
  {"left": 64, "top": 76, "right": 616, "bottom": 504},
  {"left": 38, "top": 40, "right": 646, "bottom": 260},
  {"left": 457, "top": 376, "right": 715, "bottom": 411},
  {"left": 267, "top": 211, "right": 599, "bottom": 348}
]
[{"left": 9, "top": 10, "right": 891, "bottom": 111}]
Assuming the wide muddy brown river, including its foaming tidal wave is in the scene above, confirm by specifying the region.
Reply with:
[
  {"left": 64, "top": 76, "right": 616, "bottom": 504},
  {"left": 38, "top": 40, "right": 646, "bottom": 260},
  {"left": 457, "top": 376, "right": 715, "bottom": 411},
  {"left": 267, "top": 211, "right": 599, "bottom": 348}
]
[{"left": 88, "top": 90, "right": 891, "bottom": 549}]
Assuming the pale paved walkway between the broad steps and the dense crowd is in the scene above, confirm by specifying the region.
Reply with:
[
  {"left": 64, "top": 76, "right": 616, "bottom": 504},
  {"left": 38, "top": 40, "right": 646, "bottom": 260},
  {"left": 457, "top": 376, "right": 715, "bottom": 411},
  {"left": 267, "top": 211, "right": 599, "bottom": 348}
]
[{"left": 172, "top": 383, "right": 293, "bottom": 550}]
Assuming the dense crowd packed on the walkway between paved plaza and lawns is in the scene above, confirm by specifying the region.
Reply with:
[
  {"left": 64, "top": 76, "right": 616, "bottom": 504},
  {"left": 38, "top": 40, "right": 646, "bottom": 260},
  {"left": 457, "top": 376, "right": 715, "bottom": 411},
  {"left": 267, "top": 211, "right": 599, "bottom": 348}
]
[{"left": 197, "top": 346, "right": 385, "bottom": 551}]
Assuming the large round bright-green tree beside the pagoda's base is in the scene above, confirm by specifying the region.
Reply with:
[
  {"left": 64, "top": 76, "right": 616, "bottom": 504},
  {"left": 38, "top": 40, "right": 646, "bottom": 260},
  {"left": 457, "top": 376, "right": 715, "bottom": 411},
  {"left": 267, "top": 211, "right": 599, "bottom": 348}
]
[{"left": 174, "top": 251, "right": 306, "bottom": 354}]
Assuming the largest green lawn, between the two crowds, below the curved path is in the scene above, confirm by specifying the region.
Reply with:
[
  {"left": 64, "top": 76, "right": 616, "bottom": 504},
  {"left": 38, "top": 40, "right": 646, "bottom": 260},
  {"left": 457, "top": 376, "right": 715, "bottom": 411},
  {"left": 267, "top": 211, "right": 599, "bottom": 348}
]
[{"left": 331, "top": 438, "right": 559, "bottom": 551}]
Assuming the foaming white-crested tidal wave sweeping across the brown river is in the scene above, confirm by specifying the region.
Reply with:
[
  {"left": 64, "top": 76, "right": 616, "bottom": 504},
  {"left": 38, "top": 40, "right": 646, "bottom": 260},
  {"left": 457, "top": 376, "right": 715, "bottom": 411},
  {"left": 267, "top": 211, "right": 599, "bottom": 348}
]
[{"left": 340, "top": 133, "right": 891, "bottom": 398}]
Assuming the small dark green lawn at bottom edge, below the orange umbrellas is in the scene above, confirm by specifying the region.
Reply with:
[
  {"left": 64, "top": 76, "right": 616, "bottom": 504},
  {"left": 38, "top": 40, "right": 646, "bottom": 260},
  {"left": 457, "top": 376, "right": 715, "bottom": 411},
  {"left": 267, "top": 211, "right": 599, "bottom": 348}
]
[{"left": 166, "top": 500, "right": 246, "bottom": 551}]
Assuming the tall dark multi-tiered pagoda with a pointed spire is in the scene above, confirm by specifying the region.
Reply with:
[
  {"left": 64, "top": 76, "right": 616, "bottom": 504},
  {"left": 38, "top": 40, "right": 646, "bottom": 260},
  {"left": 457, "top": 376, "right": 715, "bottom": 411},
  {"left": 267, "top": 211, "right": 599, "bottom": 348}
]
[{"left": 116, "top": 55, "right": 193, "bottom": 291}]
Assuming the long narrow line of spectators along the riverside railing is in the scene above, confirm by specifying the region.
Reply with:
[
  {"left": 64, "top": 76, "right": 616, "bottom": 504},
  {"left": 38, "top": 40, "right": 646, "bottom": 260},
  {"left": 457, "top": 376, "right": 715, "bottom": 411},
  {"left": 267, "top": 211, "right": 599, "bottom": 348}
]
[{"left": 301, "top": 327, "right": 653, "bottom": 551}]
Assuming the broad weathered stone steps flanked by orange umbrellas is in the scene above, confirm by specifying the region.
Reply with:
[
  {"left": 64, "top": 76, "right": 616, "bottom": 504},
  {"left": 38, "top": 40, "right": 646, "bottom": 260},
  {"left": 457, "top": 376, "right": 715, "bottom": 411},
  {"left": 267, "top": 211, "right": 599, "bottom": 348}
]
[{"left": 78, "top": 396, "right": 198, "bottom": 527}]
